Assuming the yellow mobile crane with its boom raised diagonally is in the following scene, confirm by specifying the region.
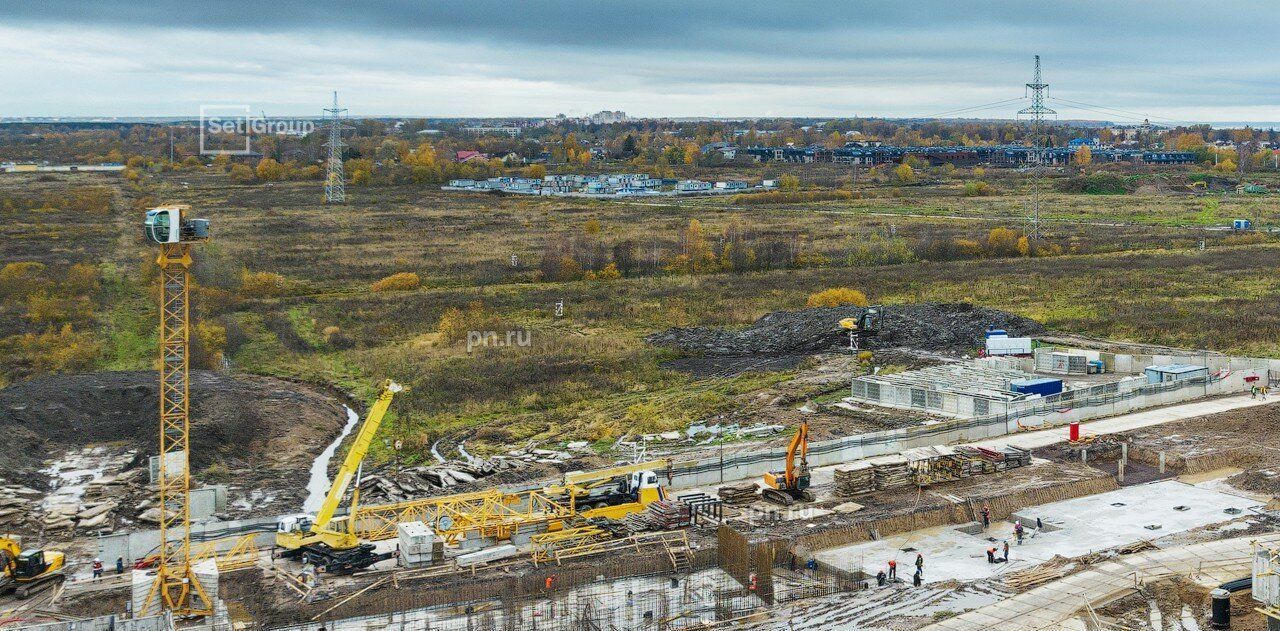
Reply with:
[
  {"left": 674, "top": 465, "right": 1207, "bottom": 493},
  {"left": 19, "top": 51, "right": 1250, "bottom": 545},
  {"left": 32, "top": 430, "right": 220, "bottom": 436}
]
[{"left": 275, "top": 379, "right": 408, "bottom": 573}]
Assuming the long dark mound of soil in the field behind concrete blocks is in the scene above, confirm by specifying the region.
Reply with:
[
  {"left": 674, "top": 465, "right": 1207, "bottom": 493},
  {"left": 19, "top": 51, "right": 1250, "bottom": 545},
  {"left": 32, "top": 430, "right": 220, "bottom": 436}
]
[{"left": 645, "top": 302, "right": 1044, "bottom": 357}]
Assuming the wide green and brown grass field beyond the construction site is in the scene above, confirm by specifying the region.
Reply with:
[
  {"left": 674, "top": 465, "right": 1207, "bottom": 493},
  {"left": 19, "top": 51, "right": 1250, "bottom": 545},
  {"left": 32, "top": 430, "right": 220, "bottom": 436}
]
[{"left": 0, "top": 166, "right": 1280, "bottom": 459}]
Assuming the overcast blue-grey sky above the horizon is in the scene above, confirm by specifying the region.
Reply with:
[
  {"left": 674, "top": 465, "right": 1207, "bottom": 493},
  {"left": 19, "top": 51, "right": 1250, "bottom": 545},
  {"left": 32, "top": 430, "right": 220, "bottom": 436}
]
[{"left": 0, "top": 0, "right": 1280, "bottom": 123}]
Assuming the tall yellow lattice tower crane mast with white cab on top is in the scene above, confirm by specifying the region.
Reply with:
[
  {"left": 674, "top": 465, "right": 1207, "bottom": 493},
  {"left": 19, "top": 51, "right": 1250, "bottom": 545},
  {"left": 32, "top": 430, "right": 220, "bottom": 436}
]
[{"left": 142, "top": 206, "right": 214, "bottom": 616}]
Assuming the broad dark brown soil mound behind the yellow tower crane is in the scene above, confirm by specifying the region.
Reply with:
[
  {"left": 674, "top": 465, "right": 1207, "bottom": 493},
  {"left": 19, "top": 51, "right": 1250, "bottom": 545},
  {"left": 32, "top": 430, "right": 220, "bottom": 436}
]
[{"left": 0, "top": 371, "right": 346, "bottom": 479}]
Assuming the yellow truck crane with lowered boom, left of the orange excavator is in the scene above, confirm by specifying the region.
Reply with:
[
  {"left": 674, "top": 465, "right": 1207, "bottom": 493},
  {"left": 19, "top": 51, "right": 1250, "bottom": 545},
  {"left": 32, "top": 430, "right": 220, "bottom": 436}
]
[{"left": 543, "top": 458, "right": 671, "bottom": 520}]
